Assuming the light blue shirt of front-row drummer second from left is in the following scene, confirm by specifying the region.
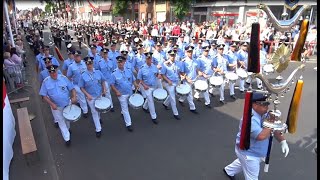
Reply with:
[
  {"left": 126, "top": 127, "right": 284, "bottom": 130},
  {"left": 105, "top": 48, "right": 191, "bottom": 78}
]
[{"left": 79, "top": 69, "right": 106, "bottom": 98}]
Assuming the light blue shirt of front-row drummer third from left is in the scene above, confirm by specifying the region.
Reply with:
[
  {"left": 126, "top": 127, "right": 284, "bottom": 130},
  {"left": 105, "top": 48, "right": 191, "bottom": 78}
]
[{"left": 110, "top": 68, "right": 136, "bottom": 95}]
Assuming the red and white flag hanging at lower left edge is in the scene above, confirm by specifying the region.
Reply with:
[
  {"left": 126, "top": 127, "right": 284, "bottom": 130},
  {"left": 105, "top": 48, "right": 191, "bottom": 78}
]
[{"left": 2, "top": 80, "right": 16, "bottom": 180}]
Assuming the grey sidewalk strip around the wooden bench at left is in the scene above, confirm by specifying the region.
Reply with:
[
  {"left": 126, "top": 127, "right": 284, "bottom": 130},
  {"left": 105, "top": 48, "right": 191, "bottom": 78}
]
[{"left": 9, "top": 31, "right": 59, "bottom": 180}]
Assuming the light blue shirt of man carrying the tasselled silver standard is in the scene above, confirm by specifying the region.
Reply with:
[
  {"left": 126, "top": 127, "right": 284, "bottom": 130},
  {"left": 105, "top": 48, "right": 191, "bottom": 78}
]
[{"left": 236, "top": 109, "right": 269, "bottom": 157}]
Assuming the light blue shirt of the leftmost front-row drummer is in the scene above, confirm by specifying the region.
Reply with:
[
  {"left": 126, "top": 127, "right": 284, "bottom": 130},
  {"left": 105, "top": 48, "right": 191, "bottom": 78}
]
[{"left": 39, "top": 74, "right": 74, "bottom": 108}]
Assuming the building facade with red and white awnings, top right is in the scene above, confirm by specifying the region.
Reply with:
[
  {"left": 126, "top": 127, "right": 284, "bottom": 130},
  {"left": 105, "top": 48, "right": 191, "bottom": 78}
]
[{"left": 191, "top": 0, "right": 317, "bottom": 25}]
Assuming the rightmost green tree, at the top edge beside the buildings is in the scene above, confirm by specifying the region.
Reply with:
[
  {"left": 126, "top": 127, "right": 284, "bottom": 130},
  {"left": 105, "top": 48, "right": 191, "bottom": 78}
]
[{"left": 171, "top": 0, "right": 193, "bottom": 21}]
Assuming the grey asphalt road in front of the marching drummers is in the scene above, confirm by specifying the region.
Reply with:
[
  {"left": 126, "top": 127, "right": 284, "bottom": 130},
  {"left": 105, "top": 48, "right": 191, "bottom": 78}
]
[{"left": 10, "top": 25, "right": 317, "bottom": 180}]
